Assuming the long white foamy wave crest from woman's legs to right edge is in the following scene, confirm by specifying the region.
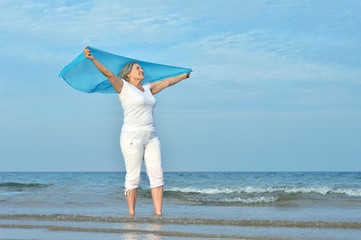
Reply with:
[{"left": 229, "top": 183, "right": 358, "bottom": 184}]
[{"left": 165, "top": 186, "right": 361, "bottom": 197}]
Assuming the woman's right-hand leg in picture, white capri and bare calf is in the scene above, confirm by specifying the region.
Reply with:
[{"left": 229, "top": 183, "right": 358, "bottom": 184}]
[{"left": 144, "top": 136, "right": 164, "bottom": 216}]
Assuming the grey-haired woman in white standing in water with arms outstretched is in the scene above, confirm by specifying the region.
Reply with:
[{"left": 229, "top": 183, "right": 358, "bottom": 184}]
[{"left": 84, "top": 47, "right": 190, "bottom": 216}]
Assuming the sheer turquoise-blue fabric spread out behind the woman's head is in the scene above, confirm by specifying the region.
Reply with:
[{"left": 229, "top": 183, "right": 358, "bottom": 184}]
[{"left": 59, "top": 47, "right": 192, "bottom": 93}]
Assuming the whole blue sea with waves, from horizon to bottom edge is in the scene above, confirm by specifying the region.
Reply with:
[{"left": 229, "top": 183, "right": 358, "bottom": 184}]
[{"left": 0, "top": 172, "right": 361, "bottom": 240}]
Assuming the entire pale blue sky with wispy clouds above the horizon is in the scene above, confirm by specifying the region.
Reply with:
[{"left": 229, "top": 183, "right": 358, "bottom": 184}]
[{"left": 0, "top": 0, "right": 361, "bottom": 171}]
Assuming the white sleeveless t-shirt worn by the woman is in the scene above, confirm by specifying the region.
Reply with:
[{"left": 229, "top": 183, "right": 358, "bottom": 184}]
[{"left": 119, "top": 80, "right": 155, "bottom": 132}]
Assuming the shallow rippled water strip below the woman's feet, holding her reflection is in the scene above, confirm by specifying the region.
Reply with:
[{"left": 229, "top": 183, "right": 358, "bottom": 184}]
[{"left": 0, "top": 214, "right": 361, "bottom": 240}]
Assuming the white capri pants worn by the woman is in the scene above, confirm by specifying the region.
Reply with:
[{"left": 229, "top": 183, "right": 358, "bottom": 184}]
[{"left": 120, "top": 131, "right": 164, "bottom": 191}]
